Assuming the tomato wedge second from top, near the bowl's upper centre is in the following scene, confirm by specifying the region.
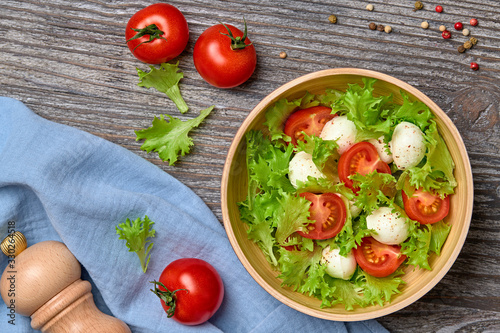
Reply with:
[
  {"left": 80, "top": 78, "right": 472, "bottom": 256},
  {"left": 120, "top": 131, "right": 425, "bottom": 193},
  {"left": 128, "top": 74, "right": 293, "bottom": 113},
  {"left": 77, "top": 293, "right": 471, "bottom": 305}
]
[{"left": 338, "top": 142, "right": 391, "bottom": 189}]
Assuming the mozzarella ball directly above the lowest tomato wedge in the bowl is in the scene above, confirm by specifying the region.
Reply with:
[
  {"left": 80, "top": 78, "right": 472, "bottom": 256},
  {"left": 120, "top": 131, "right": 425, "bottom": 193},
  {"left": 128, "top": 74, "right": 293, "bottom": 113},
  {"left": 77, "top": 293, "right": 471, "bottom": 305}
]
[{"left": 366, "top": 207, "right": 409, "bottom": 245}]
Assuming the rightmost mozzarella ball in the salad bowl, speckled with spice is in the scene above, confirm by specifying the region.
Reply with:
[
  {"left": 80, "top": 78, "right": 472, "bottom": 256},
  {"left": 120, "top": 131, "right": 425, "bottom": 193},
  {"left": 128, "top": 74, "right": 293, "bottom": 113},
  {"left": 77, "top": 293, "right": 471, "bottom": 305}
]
[{"left": 391, "top": 121, "right": 426, "bottom": 170}]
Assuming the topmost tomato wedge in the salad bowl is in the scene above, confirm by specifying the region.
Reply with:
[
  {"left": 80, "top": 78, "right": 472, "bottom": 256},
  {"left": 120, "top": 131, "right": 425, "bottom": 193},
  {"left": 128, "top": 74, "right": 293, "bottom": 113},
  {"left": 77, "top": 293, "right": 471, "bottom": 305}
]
[{"left": 285, "top": 106, "right": 337, "bottom": 146}]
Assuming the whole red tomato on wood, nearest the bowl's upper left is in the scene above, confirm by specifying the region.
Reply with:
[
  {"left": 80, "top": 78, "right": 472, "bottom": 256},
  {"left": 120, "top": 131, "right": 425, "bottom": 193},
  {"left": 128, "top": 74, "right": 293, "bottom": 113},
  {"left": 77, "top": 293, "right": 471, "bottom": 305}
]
[{"left": 193, "top": 23, "right": 257, "bottom": 88}]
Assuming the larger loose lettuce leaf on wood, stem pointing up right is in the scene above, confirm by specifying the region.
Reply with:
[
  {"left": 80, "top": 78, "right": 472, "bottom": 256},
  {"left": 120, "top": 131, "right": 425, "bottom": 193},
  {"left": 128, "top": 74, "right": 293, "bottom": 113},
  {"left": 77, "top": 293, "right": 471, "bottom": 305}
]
[{"left": 135, "top": 105, "right": 214, "bottom": 165}]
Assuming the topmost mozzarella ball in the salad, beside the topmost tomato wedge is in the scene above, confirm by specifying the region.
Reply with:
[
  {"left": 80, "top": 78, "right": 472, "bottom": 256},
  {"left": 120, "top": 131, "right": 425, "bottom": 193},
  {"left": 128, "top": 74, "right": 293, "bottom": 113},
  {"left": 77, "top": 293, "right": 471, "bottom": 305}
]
[{"left": 319, "top": 116, "right": 358, "bottom": 155}]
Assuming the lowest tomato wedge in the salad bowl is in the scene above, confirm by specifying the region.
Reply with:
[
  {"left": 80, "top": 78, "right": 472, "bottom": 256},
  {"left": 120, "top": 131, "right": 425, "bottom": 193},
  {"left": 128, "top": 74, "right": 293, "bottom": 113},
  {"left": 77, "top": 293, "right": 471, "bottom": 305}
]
[{"left": 354, "top": 237, "right": 406, "bottom": 277}]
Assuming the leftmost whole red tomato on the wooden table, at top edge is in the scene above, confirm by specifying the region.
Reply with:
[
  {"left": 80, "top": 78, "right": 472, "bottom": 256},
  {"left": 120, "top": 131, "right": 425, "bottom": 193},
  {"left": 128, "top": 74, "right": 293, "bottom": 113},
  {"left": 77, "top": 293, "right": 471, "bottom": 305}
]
[{"left": 125, "top": 3, "right": 189, "bottom": 64}]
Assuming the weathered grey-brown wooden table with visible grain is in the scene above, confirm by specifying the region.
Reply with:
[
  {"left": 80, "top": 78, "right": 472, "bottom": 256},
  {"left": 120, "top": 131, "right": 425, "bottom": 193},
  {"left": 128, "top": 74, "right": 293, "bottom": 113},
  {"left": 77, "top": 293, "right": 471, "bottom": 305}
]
[{"left": 0, "top": 0, "right": 500, "bottom": 332}]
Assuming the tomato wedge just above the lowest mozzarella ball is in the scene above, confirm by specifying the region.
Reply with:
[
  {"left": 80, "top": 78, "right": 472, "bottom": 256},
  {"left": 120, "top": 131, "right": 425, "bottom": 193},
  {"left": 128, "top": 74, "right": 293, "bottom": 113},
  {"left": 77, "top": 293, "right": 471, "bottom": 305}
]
[{"left": 298, "top": 192, "right": 347, "bottom": 239}]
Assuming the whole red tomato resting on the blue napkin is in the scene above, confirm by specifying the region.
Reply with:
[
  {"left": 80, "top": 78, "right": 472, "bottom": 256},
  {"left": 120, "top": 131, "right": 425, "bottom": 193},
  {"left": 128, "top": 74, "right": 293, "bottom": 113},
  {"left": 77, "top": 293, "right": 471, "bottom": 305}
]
[{"left": 151, "top": 258, "right": 224, "bottom": 325}]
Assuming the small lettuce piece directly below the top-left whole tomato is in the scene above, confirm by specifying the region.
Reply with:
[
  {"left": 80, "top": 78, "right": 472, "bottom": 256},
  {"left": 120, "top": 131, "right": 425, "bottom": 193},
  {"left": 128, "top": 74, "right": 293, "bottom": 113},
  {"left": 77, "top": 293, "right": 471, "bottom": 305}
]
[{"left": 137, "top": 62, "right": 189, "bottom": 113}]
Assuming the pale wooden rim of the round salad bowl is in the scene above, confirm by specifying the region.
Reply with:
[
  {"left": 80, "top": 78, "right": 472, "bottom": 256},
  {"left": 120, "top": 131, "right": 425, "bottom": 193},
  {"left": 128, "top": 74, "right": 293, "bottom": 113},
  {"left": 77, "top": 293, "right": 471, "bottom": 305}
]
[{"left": 221, "top": 68, "right": 474, "bottom": 321}]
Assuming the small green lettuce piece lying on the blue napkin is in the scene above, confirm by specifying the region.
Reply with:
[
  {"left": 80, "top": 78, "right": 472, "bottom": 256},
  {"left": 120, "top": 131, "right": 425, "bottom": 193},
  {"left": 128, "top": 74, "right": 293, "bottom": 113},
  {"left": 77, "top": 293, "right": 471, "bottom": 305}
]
[{"left": 116, "top": 215, "right": 156, "bottom": 273}]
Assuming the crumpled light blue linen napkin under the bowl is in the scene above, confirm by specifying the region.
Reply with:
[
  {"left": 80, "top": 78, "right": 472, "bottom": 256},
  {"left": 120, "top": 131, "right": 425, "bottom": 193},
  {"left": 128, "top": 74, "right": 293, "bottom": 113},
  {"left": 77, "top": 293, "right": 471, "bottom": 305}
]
[{"left": 0, "top": 97, "right": 386, "bottom": 333}]
